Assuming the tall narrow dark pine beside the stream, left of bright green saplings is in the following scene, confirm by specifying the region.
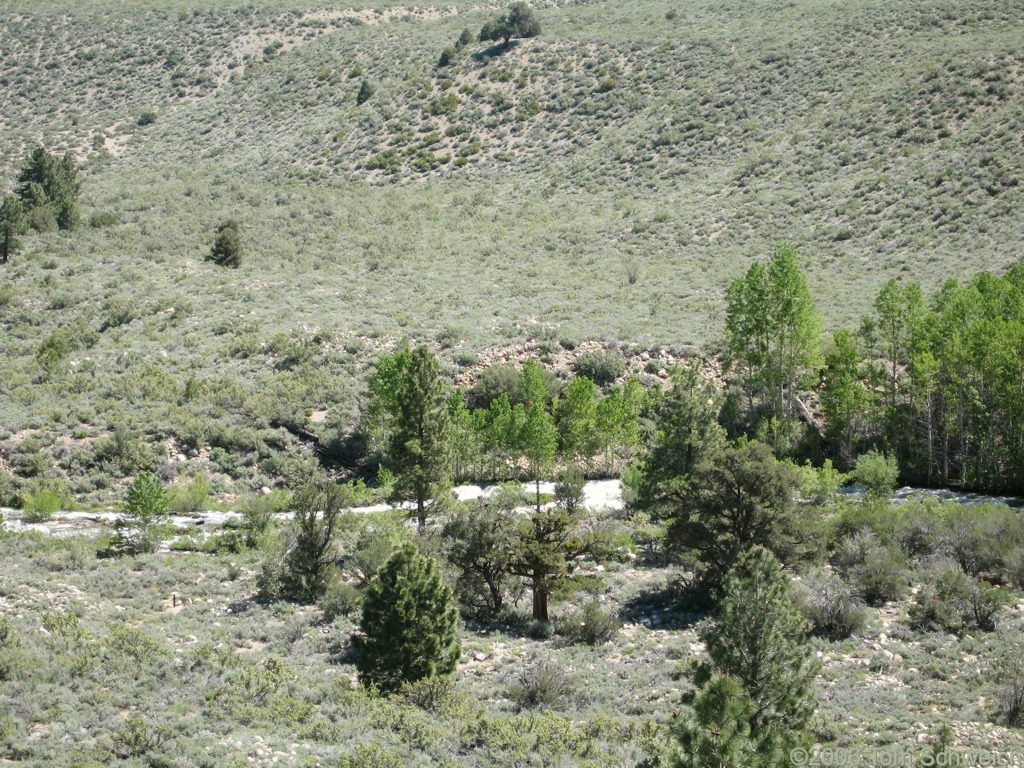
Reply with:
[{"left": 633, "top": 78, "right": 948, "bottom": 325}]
[{"left": 388, "top": 346, "right": 451, "bottom": 530}]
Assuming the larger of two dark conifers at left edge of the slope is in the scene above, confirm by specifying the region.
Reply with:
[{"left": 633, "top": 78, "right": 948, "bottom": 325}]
[{"left": 16, "top": 146, "right": 81, "bottom": 231}]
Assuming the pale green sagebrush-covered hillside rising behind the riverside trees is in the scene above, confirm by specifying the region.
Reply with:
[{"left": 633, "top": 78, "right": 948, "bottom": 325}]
[{"left": 0, "top": 0, "right": 1024, "bottom": 499}]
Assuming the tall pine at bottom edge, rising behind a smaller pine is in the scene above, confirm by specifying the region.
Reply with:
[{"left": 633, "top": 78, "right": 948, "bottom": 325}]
[{"left": 679, "top": 547, "right": 817, "bottom": 768}]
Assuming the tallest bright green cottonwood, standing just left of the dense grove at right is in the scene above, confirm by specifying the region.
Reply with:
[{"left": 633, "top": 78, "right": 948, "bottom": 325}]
[{"left": 725, "top": 244, "right": 821, "bottom": 424}]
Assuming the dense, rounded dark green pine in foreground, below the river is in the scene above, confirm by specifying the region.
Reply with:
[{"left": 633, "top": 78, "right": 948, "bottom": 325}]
[{"left": 352, "top": 544, "right": 462, "bottom": 692}]
